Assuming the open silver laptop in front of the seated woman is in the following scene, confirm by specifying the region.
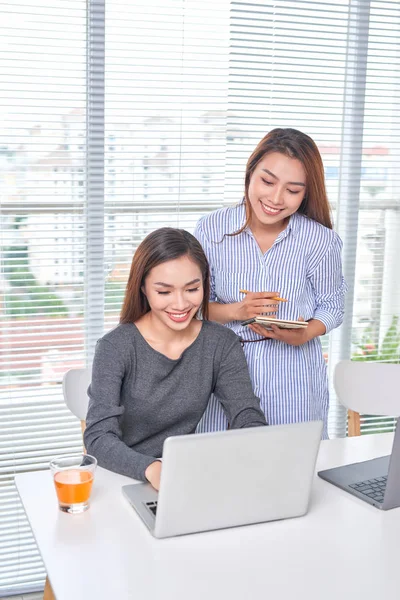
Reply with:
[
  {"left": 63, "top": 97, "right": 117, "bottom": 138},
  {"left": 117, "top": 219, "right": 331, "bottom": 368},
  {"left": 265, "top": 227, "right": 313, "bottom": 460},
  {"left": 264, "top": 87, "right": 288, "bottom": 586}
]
[{"left": 122, "top": 421, "right": 322, "bottom": 538}]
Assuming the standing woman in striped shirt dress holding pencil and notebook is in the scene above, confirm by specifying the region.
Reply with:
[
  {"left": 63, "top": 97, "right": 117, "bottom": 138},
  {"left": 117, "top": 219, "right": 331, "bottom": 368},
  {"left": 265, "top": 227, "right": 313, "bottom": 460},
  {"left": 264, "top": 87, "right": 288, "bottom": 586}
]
[{"left": 195, "top": 129, "right": 346, "bottom": 438}]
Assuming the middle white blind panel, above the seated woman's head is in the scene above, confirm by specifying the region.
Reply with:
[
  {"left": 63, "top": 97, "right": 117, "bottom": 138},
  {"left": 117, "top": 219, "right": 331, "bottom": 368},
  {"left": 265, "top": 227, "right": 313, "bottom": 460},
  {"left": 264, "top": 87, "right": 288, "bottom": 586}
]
[{"left": 104, "top": 0, "right": 230, "bottom": 327}]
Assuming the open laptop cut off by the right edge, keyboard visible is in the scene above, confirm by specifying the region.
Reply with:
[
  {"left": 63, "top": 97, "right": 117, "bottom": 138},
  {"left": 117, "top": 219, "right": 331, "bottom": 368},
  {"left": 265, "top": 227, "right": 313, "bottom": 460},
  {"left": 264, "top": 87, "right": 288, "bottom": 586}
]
[{"left": 318, "top": 419, "right": 400, "bottom": 510}]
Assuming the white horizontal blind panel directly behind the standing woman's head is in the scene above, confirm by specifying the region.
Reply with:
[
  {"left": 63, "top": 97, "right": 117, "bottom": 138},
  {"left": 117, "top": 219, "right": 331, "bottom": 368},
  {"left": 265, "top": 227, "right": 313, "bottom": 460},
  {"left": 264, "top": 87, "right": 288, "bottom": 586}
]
[{"left": 227, "top": 0, "right": 350, "bottom": 435}]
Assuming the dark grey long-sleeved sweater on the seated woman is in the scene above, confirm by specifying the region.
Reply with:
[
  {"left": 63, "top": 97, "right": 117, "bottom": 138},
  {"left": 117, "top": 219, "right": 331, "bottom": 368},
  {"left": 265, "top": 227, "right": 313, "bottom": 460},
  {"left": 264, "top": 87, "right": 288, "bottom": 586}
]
[{"left": 84, "top": 321, "right": 266, "bottom": 480}]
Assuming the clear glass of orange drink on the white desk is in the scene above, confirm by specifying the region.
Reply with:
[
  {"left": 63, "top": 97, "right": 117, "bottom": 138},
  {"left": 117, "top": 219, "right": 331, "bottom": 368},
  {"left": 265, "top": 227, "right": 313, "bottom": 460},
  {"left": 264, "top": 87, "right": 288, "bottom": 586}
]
[{"left": 50, "top": 454, "right": 97, "bottom": 514}]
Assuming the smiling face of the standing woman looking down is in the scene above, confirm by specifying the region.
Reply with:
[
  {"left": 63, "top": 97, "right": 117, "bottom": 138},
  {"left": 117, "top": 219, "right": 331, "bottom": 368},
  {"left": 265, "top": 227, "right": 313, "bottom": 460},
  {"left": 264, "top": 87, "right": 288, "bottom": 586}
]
[{"left": 248, "top": 152, "right": 306, "bottom": 229}]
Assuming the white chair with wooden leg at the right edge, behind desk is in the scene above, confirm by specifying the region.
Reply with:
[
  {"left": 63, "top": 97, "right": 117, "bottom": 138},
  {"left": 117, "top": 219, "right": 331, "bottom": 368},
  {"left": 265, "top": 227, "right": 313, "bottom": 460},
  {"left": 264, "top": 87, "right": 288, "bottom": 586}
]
[{"left": 333, "top": 360, "right": 400, "bottom": 436}]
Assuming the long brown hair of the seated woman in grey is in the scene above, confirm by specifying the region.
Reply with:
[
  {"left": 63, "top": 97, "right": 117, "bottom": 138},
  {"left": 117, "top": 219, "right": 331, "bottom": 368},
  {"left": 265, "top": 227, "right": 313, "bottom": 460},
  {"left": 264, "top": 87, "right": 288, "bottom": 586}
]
[{"left": 119, "top": 227, "right": 210, "bottom": 323}]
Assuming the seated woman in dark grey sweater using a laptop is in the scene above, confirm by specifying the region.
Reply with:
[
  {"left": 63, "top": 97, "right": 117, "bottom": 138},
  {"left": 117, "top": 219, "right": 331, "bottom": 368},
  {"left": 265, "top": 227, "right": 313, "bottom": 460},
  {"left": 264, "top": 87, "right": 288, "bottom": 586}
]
[{"left": 84, "top": 227, "right": 266, "bottom": 489}]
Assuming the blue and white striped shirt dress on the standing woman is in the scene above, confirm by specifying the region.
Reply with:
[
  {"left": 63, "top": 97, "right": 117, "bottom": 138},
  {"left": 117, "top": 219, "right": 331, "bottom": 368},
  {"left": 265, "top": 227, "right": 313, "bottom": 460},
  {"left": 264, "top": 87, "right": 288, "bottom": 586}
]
[{"left": 195, "top": 203, "right": 347, "bottom": 437}]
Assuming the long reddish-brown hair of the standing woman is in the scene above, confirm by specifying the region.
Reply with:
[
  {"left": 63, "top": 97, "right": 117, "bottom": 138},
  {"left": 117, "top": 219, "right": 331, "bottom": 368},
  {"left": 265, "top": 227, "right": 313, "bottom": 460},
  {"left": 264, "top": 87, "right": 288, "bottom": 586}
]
[{"left": 233, "top": 128, "right": 332, "bottom": 235}]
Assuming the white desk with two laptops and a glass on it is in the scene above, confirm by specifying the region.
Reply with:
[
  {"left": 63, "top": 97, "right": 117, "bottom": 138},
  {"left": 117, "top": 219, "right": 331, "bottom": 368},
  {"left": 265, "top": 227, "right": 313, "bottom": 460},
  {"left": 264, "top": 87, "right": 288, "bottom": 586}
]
[{"left": 16, "top": 434, "right": 400, "bottom": 600}]
